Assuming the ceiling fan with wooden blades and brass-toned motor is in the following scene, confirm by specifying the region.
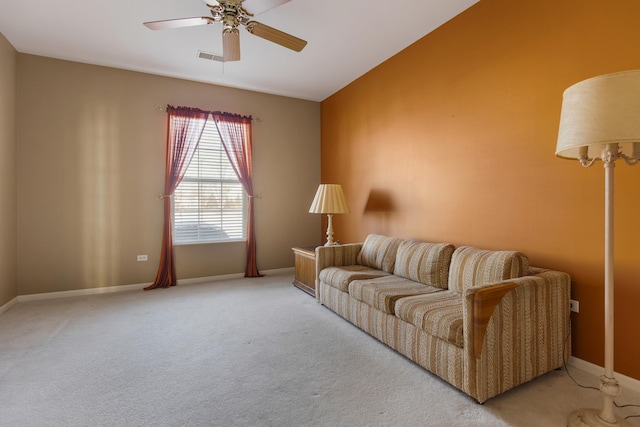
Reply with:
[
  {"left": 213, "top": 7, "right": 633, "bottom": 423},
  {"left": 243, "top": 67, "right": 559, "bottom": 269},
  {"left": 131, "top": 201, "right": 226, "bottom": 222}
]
[{"left": 144, "top": 0, "right": 307, "bottom": 62}]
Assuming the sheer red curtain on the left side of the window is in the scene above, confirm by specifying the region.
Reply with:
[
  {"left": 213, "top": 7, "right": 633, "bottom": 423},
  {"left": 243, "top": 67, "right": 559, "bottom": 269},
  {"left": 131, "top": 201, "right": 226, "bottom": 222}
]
[{"left": 144, "top": 105, "right": 210, "bottom": 291}]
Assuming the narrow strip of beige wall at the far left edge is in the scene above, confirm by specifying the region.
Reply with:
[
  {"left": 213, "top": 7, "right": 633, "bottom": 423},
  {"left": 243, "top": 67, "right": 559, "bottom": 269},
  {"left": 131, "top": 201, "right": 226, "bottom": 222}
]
[{"left": 0, "top": 33, "right": 17, "bottom": 307}]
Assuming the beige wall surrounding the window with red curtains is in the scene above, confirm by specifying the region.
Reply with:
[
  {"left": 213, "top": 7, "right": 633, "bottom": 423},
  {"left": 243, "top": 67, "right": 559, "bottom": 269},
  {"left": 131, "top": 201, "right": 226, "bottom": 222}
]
[{"left": 17, "top": 54, "right": 320, "bottom": 294}]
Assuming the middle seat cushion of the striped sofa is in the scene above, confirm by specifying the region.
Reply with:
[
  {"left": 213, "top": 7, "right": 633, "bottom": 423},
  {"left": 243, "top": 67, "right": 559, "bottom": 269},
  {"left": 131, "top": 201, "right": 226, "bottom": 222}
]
[{"left": 349, "top": 276, "right": 442, "bottom": 314}]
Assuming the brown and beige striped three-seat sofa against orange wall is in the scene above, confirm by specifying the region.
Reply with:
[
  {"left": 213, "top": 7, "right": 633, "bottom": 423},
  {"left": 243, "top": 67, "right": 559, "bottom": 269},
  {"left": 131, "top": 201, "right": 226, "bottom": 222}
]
[{"left": 316, "top": 234, "right": 570, "bottom": 403}]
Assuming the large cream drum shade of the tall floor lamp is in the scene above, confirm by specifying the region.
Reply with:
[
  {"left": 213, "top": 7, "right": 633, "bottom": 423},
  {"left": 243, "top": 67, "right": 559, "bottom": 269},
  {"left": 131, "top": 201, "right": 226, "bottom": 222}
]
[{"left": 556, "top": 70, "right": 640, "bottom": 159}]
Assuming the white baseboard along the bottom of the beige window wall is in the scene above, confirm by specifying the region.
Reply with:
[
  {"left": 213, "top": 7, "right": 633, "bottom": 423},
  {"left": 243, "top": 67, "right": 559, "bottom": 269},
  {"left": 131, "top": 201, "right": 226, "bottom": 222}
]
[{"left": 5, "top": 267, "right": 294, "bottom": 306}]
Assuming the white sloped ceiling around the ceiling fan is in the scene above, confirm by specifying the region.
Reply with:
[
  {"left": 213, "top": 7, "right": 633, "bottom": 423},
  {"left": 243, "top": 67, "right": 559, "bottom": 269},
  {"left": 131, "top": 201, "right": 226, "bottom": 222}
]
[{"left": 0, "top": 0, "right": 479, "bottom": 101}]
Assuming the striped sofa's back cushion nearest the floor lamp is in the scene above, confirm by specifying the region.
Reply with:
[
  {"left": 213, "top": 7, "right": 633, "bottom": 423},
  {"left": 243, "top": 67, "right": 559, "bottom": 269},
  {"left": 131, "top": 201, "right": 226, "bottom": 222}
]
[{"left": 449, "top": 246, "right": 529, "bottom": 293}]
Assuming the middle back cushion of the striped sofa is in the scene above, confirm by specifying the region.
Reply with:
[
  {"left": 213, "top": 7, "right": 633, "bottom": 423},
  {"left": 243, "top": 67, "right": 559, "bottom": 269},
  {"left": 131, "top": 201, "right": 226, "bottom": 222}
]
[{"left": 393, "top": 240, "right": 454, "bottom": 289}]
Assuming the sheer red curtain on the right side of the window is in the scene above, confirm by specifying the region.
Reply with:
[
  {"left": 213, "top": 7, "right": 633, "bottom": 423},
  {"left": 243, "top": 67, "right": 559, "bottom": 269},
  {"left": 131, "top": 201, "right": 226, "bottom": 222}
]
[{"left": 212, "top": 112, "right": 262, "bottom": 277}]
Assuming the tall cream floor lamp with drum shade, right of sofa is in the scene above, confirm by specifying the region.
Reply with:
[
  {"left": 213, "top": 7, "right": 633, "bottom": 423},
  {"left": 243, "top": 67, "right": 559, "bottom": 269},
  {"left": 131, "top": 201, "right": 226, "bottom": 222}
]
[{"left": 556, "top": 70, "right": 640, "bottom": 427}]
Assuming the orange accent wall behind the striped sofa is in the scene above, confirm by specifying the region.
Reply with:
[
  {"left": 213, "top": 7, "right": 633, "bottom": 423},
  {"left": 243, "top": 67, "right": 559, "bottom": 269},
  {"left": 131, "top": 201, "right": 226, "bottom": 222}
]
[{"left": 322, "top": 0, "right": 640, "bottom": 379}]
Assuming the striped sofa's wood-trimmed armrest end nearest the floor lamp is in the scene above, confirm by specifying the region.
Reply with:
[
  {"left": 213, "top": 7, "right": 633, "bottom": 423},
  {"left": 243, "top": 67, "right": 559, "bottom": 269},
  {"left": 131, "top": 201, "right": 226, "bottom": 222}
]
[{"left": 463, "top": 268, "right": 571, "bottom": 402}]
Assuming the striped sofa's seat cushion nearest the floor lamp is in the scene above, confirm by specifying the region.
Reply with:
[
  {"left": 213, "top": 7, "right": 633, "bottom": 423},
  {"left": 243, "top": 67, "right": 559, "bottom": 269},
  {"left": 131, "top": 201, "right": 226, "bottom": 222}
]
[{"left": 395, "top": 291, "right": 464, "bottom": 347}]
